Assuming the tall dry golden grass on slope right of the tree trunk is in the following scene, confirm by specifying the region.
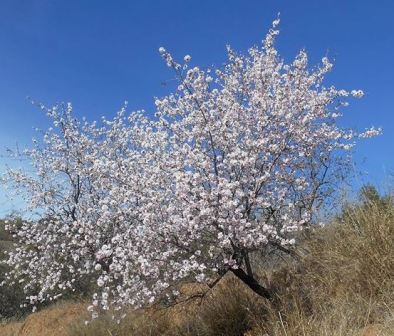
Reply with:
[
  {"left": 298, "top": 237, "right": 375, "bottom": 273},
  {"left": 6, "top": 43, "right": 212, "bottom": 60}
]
[{"left": 250, "top": 200, "right": 394, "bottom": 336}]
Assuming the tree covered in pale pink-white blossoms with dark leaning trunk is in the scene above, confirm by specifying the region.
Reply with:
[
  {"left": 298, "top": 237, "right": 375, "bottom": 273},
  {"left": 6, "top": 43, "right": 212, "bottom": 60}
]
[{"left": 4, "top": 20, "right": 379, "bottom": 315}]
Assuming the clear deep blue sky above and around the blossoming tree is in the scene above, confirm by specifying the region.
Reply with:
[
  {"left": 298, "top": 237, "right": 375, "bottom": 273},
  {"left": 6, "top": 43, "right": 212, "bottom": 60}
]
[{"left": 0, "top": 0, "right": 394, "bottom": 216}]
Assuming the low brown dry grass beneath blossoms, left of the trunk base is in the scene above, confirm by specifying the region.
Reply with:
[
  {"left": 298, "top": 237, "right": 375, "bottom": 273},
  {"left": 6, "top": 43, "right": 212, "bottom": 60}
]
[{"left": 70, "top": 276, "right": 267, "bottom": 336}]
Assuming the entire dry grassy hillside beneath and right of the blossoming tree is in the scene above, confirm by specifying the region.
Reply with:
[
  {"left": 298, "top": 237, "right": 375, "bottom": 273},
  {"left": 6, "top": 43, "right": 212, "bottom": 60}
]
[{"left": 49, "top": 188, "right": 394, "bottom": 336}]
